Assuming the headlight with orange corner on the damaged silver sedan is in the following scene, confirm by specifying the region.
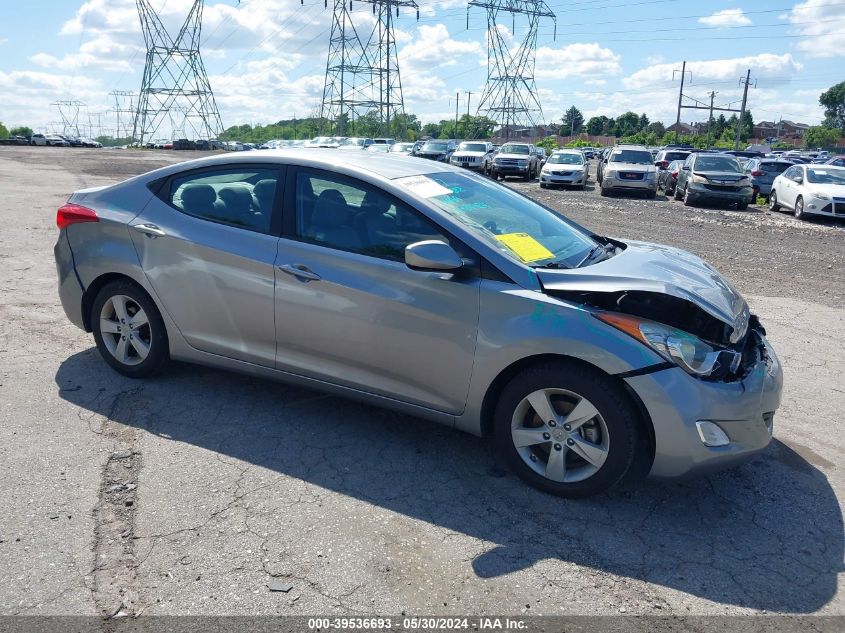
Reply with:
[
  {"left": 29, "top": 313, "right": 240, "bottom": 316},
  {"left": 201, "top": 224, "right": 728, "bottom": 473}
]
[{"left": 595, "top": 312, "right": 742, "bottom": 378}]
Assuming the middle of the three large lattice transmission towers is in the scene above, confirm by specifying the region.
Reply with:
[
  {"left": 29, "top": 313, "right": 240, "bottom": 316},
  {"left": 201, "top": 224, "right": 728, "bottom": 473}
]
[{"left": 320, "top": 0, "right": 420, "bottom": 135}]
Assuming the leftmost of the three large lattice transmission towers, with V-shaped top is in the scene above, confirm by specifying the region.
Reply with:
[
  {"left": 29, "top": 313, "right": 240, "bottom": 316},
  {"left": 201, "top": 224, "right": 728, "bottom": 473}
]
[{"left": 132, "top": 0, "right": 223, "bottom": 145}]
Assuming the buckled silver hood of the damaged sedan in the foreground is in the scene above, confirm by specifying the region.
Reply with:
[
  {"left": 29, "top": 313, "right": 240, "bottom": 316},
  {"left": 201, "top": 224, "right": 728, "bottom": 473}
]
[{"left": 537, "top": 241, "right": 750, "bottom": 342}]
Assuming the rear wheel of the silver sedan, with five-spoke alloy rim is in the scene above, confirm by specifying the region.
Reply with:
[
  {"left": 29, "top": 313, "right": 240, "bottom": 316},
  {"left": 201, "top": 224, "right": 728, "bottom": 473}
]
[{"left": 91, "top": 280, "right": 169, "bottom": 378}]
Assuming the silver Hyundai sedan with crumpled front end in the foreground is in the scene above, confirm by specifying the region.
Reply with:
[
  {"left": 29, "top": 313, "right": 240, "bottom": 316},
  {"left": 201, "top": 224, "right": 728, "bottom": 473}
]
[{"left": 55, "top": 150, "right": 782, "bottom": 497}]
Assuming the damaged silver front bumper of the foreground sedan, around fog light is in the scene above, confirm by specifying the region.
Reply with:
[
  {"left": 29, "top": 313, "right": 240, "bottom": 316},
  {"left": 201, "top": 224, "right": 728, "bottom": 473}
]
[{"left": 625, "top": 330, "right": 783, "bottom": 477}]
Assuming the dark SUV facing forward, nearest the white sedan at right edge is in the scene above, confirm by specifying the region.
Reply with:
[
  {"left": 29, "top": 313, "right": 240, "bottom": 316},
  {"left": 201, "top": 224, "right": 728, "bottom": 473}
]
[{"left": 674, "top": 153, "right": 754, "bottom": 211}]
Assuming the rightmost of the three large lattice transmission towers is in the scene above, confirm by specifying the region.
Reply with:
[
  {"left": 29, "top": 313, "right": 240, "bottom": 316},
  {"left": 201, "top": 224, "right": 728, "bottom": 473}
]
[{"left": 467, "top": 0, "right": 557, "bottom": 138}]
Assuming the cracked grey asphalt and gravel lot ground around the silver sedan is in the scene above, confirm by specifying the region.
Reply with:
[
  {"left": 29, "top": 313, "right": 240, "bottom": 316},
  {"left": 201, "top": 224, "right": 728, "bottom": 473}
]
[{"left": 0, "top": 147, "right": 845, "bottom": 616}]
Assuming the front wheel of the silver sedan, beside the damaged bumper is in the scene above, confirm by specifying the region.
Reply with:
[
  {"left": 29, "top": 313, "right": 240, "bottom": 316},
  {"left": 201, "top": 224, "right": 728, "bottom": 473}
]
[{"left": 494, "top": 362, "right": 639, "bottom": 497}]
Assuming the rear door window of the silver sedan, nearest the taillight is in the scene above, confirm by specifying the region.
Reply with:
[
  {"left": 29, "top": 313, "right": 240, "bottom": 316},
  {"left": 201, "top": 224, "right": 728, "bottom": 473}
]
[{"left": 167, "top": 167, "right": 280, "bottom": 233}]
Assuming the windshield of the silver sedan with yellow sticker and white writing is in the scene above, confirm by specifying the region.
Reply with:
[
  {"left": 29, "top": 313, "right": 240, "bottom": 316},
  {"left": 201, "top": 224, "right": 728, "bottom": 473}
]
[{"left": 397, "top": 172, "right": 597, "bottom": 267}]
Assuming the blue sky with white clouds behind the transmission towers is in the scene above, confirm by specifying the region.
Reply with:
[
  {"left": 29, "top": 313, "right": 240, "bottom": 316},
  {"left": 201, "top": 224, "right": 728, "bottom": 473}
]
[{"left": 0, "top": 0, "right": 845, "bottom": 133}]
